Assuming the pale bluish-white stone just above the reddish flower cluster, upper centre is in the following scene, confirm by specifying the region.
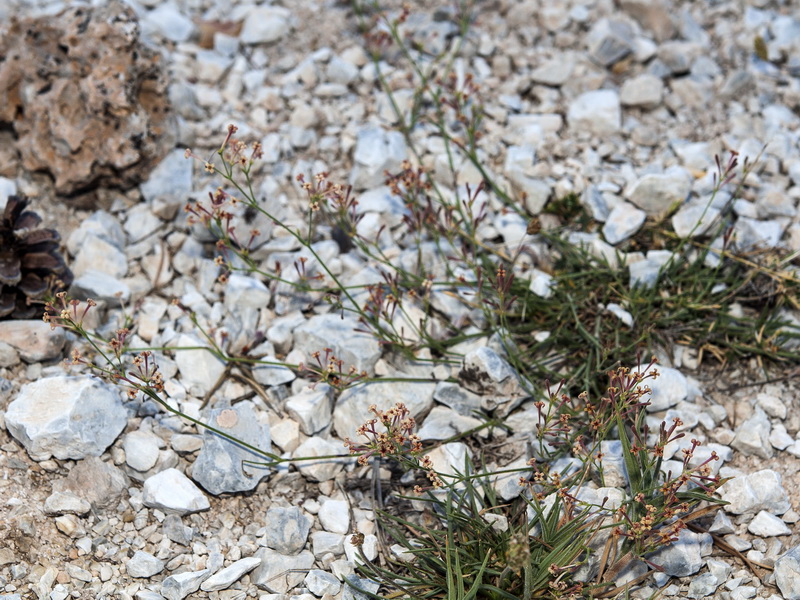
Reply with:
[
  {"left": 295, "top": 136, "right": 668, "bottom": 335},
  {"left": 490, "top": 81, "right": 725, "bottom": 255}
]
[{"left": 350, "top": 127, "right": 408, "bottom": 190}]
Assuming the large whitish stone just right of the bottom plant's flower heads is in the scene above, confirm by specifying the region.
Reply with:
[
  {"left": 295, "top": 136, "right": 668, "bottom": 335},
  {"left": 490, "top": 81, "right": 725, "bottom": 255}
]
[{"left": 719, "top": 469, "right": 791, "bottom": 515}]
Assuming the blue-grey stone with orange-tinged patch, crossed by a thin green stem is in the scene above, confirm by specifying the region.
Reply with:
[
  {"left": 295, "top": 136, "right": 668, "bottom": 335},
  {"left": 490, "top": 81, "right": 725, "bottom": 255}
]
[{"left": 192, "top": 401, "right": 272, "bottom": 496}]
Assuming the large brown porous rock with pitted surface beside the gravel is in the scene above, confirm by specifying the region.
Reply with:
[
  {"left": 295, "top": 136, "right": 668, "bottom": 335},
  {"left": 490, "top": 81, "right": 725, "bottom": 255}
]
[{"left": 0, "top": 0, "right": 176, "bottom": 204}]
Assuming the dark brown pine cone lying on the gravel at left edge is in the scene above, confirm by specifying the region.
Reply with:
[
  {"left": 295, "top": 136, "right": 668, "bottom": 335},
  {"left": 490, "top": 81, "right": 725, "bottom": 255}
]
[{"left": 0, "top": 196, "right": 72, "bottom": 319}]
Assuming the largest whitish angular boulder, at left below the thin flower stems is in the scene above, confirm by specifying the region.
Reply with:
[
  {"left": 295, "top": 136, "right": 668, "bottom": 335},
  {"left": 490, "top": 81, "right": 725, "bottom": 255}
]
[{"left": 5, "top": 376, "right": 128, "bottom": 460}]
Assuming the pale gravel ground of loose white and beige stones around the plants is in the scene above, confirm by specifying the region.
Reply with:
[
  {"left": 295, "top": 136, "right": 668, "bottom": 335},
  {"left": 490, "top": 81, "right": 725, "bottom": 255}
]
[{"left": 0, "top": 0, "right": 800, "bottom": 600}]
